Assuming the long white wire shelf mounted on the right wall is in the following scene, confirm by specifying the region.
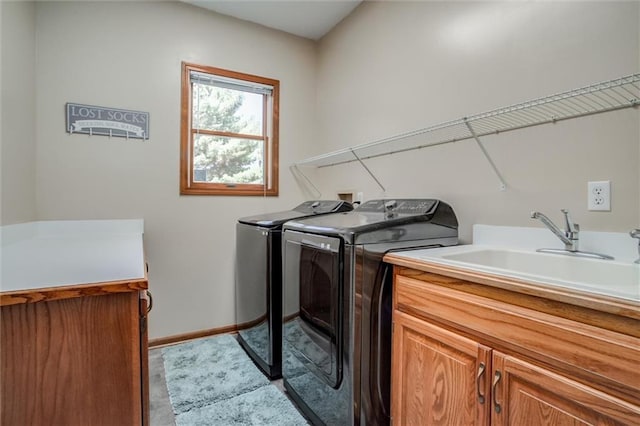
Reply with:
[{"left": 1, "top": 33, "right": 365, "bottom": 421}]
[{"left": 294, "top": 74, "right": 640, "bottom": 168}]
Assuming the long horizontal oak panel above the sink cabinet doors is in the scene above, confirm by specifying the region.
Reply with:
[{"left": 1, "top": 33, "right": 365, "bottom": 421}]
[{"left": 394, "top": 275, "right": 640, "bottom": 399}]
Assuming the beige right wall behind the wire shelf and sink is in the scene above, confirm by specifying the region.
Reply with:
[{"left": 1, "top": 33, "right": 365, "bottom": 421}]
[{"left": 312, "top": 2, "right": 640, "bottom": 241}]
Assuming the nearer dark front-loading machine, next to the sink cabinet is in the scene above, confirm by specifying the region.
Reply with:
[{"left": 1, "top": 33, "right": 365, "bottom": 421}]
[{"left": 282, "top": 199, "right": 458, "bottom": 426}]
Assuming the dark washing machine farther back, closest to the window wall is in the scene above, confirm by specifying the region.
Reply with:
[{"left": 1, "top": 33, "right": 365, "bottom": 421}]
[{"left": 235, "top": 200, "right": 353, "bottom": 379}]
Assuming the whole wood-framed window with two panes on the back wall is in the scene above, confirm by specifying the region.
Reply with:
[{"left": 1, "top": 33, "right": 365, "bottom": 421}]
[{"left": 180, "top": 62, "right": 280, "bottom": 195}]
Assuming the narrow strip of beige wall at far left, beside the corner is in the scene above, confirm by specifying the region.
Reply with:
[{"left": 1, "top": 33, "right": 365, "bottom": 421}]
[{"left": 0, "top": 2, "right": 36, "bottom": 225}]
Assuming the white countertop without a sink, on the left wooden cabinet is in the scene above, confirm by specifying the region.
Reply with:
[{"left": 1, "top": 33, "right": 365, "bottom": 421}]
[{"left": 0, "top": 219, "right": 145, "bottom": 292}]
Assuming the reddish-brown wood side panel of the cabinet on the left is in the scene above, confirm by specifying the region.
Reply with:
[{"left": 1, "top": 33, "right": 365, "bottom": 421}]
[{"left": 0, "top": 291, "right": 142, "bottom": 426}]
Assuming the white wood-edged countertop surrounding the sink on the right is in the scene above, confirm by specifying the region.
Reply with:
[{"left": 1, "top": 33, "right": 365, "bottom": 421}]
[{"left": 384, "top": 225, "right": 640, "bottom": 318}]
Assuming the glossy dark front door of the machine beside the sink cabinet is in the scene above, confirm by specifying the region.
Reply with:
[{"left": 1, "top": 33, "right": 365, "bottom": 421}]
[{"left": 283, "top": 231, "right": 343, "bottom": 388}]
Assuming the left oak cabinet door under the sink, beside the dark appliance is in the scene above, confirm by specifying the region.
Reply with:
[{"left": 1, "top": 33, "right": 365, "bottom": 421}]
[{"left": 391, "top": 311, "right": 491, "bottom": 426}]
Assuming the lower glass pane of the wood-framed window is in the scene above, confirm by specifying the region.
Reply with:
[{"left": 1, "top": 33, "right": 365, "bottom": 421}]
[{"left": 193, "top": 134, "right": 264, "bottom": 184}]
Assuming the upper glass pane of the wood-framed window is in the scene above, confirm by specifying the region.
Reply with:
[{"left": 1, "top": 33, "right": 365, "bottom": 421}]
[{"left": 193, "top": 83, "right": 264, "bottom": 136}]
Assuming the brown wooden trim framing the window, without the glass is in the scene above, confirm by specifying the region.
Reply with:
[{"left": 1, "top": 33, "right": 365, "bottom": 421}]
[{"left": 180, "top": 62, "right": 280, "bottom": 196}]
